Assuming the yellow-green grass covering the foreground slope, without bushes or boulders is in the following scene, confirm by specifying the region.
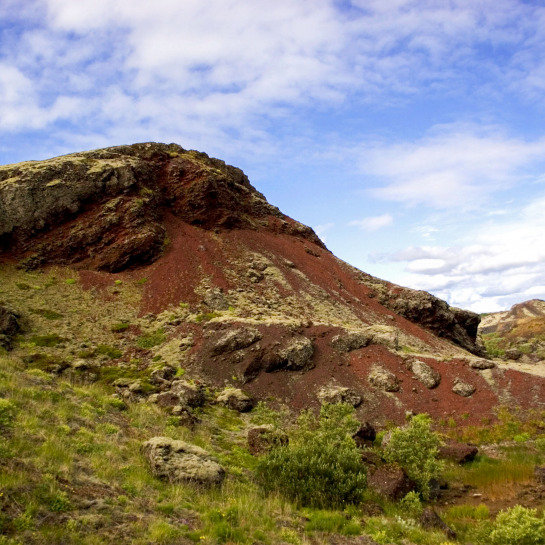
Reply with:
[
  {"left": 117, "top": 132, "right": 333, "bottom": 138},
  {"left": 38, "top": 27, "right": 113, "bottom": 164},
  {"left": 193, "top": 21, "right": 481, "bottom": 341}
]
[{"left": 0, "top": 267, "right": 543, "bottom": 545}]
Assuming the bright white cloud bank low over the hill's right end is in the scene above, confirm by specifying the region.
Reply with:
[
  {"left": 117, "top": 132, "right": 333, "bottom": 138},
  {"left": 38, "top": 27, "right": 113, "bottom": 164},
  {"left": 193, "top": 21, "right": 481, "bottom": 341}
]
[{"left": 383, "top": 196, "right": 545, "bottom": 312}]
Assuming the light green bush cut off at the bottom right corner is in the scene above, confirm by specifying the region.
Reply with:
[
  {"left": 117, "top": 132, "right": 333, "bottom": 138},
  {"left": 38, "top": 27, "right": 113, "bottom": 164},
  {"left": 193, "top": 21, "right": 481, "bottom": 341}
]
[{"left": 490, "top": 505, "right": 545, "bottom": 545}]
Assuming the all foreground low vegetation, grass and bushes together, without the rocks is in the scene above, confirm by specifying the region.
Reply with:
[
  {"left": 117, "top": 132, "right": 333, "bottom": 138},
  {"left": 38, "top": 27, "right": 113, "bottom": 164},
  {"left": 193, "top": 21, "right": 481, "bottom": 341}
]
[{"left": 0, "top": 262, "right": 545, "bottom": 545}]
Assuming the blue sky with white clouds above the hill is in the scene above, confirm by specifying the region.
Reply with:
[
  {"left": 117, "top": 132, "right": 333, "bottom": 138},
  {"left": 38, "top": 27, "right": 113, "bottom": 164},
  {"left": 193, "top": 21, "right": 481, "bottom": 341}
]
[{"left": 0, "top": 0, "right": 545, "bottom": 312}]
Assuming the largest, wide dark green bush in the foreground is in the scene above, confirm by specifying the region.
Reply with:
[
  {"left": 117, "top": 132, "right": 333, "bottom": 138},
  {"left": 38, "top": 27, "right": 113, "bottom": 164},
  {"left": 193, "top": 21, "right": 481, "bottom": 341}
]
[{"left": 256, "top": 404, "right": 366, "bottom": 508}]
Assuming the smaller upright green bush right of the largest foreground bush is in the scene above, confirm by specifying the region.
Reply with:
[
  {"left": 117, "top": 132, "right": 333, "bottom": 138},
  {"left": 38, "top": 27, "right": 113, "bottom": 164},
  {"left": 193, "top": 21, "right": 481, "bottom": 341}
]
[{"left": 384, "top": 414, "right": 443, "bottom": 499}]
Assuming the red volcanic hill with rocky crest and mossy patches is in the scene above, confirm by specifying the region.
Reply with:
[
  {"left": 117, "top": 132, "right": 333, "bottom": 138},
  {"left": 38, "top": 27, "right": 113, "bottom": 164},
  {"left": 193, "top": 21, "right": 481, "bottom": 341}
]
[{"left": 0, "top": 143, "right": 545, "bottom": 422}]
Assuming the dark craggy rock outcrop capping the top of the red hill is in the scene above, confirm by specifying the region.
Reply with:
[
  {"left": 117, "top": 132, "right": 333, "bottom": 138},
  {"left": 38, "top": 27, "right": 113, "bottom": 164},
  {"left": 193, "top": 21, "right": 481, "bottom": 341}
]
[{"left": 0, "top": 143, "right": 323, "bottom": 272}]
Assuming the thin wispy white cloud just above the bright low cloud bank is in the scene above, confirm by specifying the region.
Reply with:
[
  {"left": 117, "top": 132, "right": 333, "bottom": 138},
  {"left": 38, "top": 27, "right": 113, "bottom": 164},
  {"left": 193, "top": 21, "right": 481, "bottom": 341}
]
[{"left": 361, "top": 124, "right": 545, "bottom": 209}]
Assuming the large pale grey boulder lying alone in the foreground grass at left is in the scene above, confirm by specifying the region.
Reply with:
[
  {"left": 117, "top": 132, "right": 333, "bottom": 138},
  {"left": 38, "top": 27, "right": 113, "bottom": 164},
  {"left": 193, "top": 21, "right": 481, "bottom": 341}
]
[{"left": 142, "top": 437, "right": 225, "bottom": 485}]
